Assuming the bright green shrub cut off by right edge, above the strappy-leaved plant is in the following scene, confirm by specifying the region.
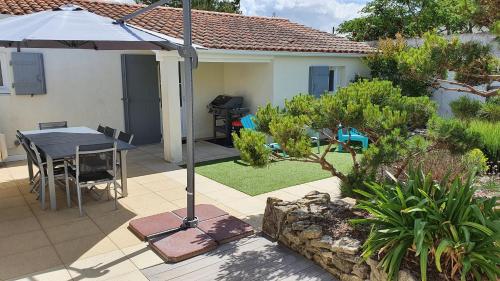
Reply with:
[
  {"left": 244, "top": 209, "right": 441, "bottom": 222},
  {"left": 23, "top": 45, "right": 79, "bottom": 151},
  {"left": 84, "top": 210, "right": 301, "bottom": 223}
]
[{"left": 468, "top": 120, "right": 500, "bottom": 162}]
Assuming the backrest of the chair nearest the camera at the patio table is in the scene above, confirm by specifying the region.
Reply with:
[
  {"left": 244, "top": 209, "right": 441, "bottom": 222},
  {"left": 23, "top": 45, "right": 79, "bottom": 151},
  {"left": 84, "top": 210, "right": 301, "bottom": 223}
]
[{"left": 75, "top": 142, "right": 116, "bottom": 177}]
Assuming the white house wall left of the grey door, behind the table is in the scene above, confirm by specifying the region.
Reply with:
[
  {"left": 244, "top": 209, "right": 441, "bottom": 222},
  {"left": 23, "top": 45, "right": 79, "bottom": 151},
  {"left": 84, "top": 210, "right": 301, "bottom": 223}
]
[{"left": 0, "top": 48, "right": 152, "bottom": 156}]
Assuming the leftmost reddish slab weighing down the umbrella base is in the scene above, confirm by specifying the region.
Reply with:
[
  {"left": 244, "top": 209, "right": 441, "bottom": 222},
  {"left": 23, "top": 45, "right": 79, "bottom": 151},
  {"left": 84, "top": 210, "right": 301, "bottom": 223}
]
[{"left": 129, "top": 212, "right": 182, "bottom": 240}]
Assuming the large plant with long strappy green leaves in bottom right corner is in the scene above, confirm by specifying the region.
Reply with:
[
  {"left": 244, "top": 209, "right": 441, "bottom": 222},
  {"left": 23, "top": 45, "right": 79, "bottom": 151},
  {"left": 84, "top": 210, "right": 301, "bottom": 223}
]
[{"left": 353, "top": 169, "right": 500, "bottom": 280}]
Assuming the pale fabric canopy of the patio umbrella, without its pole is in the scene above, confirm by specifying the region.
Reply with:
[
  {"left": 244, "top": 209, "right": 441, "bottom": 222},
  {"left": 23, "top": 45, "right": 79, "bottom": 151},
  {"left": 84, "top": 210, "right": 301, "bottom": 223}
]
[{"left": 0, "top": 4, "right": 183, "bottom": 50}]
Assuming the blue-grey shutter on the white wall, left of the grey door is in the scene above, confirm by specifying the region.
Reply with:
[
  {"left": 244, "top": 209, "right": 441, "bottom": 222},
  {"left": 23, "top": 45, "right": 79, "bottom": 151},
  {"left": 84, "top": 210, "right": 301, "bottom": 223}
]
[{"left": 11, "top": 53, "right": 47, "bottom": 95}]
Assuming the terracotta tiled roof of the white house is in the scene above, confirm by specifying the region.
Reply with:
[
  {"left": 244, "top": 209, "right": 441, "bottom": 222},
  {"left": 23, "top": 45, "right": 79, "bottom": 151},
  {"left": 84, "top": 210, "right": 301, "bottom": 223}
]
[{"left": 0, "top": 0, "right": 373, "bottom": 54}]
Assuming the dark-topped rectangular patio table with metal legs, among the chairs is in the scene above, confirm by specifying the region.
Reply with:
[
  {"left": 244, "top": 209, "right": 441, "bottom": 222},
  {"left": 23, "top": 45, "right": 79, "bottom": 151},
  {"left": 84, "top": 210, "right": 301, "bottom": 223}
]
[{"left": 21, "top": 127, "right": 135, "bottom": 210}]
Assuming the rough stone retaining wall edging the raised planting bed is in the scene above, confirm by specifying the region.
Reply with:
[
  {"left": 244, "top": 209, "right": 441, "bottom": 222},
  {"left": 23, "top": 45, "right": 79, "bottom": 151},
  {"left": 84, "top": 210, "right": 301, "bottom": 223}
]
[{"left": 262, "top": 191, "right": 417, "bottom": 281}]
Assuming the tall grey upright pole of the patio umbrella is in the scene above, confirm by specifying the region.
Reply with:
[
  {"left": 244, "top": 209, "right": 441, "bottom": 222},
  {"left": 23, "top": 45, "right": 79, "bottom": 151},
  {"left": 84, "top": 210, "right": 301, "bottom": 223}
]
[{"left": 182, "top": 0, "right": 198, "bottom": 227}]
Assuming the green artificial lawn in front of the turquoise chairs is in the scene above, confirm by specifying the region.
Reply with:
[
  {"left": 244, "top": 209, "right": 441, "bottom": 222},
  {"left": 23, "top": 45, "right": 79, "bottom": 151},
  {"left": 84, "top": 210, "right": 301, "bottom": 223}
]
[{"left": 196, "top": 146, "right": 352, "bottom": 196}]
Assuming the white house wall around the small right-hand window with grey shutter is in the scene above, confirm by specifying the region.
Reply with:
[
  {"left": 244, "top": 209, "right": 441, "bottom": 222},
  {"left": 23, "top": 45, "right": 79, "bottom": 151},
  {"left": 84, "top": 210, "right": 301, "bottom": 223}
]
[{"left": 273, "top": 56, "right": 370, "bottom": 106}]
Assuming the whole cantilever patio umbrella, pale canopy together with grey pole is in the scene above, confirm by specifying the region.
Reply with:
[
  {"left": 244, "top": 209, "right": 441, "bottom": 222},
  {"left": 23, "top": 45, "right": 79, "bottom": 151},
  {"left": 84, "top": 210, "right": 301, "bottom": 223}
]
[{"left": 0, "top": 0, "right": 202, "bottom": 227}]
